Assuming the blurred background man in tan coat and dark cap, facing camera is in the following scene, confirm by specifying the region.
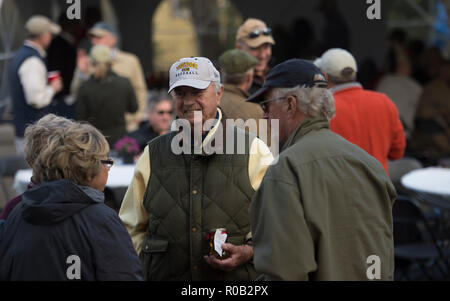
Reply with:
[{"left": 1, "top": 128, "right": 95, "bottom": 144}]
[{"left": 71, "top": 22, "right": 147, "bottom": 132}]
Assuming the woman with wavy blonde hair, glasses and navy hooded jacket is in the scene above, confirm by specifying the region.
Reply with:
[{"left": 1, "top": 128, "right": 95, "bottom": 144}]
[{"left": 0, "top": 123, "right": 142, "bottom": 281}]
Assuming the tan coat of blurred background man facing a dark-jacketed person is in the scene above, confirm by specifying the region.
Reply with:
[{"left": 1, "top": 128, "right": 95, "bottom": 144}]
[{"left": 71, "top": 49, "right": 147, "bottom": 132}]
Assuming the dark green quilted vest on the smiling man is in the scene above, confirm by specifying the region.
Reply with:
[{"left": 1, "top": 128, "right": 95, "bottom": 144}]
[{"left": 140, "top": 123, "right": 257, "bottom": 280}]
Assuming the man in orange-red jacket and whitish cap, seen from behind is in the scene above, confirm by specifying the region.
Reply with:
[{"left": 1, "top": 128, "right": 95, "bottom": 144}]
[{"left": 314, "top": 48, "right": 406, "bottom": 173}]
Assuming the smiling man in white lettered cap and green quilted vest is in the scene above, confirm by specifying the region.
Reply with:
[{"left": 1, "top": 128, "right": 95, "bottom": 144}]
[{"left": 119, "top": 57, "right": 273, "bottom": 280}]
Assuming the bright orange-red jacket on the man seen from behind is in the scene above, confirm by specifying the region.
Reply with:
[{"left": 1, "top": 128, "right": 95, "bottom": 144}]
[{"left": 330, "top": 83, "right": 406, "bottom": 173}]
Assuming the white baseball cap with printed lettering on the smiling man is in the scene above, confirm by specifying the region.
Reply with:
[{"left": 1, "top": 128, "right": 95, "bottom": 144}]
[{"left": 168, "top": 57, "right": 220, "bottom": 93}]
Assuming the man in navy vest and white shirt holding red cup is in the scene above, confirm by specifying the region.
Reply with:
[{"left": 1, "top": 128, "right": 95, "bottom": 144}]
[{"left": 9, "top": 15, "right": 63, "bottom": 155}]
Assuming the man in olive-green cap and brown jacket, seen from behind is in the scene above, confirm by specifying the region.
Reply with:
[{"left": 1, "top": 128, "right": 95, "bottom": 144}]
[{"left": 219, "top": 49, "right": 263, "bottom": 135}]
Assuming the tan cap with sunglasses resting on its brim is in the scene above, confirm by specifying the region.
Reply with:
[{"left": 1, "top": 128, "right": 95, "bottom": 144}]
[{"left": 236, "top": 18, "right": 275, "bottom": 48}]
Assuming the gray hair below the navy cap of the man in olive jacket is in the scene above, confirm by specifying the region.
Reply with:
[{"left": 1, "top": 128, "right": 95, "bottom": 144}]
[{"left": 274, "top": 86, "right": 336, "bottom": 120}]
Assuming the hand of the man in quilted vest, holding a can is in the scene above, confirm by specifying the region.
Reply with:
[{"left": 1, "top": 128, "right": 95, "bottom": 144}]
[{"left": 204, "top": 243, "right": 253, "bottom": 272}]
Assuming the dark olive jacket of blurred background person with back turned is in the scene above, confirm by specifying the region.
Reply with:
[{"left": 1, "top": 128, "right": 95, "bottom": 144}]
[{"left": 76, "top": 71, "right": 138, "bottom": 148}]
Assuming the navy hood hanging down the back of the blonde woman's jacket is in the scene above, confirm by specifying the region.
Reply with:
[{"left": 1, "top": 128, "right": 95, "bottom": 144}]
[{"left": 22, "top": 180, "right": 104, "bottom": 225}]
